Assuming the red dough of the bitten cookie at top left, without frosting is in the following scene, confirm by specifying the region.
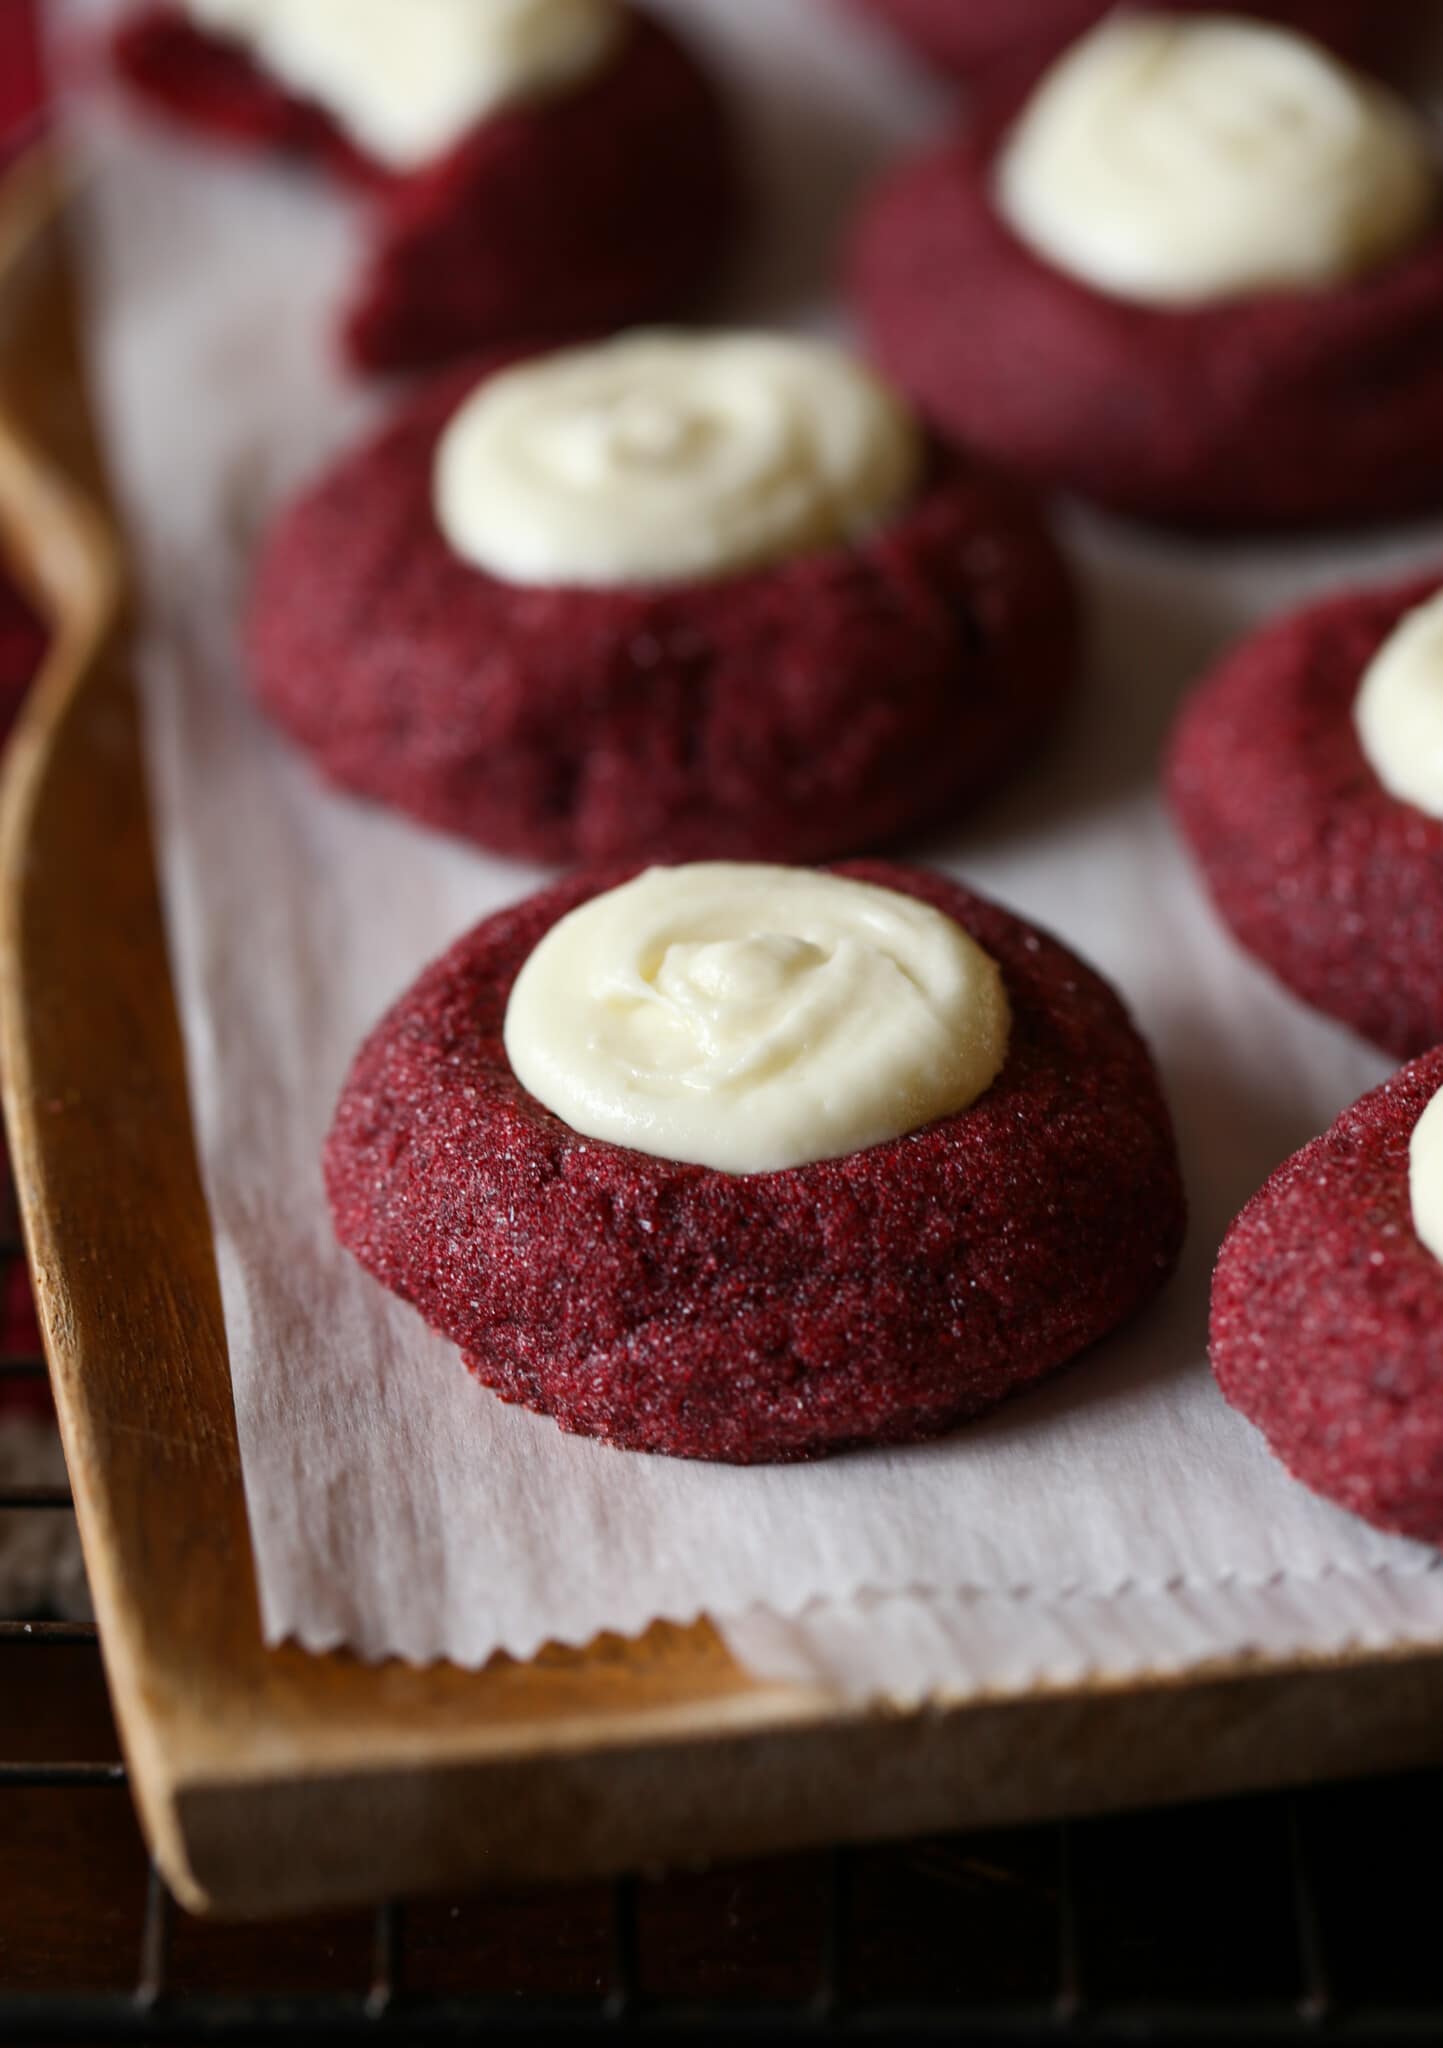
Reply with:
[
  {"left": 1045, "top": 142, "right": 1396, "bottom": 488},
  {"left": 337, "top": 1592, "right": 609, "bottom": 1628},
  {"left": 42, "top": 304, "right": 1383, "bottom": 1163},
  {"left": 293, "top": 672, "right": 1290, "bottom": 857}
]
[{"left": 117, "top": 6, "right": 739, "bottom": 371}]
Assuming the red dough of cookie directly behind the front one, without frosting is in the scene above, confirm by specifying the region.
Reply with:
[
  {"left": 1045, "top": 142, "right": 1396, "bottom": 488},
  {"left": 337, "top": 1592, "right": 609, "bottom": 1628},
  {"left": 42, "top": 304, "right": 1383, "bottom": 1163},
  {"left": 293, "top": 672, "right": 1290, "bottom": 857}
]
[{"left": 250, "top": 360, "right": 1079, "bottom": 862}]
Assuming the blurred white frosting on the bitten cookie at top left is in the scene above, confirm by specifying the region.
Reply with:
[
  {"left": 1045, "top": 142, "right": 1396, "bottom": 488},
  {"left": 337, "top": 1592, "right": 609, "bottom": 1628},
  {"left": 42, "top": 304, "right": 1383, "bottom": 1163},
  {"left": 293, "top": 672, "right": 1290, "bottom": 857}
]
[{"left": 184, "top": 0, "right": 624, "bottom": 170}]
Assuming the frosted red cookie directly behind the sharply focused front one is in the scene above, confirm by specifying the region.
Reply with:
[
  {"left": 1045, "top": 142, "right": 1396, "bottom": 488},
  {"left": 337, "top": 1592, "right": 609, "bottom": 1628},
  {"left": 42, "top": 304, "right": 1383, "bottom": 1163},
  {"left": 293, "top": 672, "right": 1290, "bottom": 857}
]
[{"left": 250, "top": 332, "right": 1079, "bottom": 862}]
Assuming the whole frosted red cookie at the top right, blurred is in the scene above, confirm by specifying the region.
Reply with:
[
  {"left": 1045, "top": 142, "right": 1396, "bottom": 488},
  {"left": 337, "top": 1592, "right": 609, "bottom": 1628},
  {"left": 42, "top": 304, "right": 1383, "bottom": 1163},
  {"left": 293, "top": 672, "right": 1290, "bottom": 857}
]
[{"left": 851, "top": 10, "right": 1443, "bottom": 530}]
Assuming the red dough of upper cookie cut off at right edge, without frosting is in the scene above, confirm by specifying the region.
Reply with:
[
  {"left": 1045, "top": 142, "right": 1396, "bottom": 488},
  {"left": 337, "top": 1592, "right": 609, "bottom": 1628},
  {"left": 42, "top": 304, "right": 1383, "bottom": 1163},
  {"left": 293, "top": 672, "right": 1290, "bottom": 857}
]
[{"left": 1167, "top": 573, "right": 1443, "bottom": 1059}]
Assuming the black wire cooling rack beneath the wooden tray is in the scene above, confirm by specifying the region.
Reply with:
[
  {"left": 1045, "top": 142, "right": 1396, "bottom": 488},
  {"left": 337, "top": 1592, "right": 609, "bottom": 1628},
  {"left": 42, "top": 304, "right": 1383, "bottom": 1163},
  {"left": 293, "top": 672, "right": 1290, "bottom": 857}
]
[{"left": 0, "top": 1204, "right": 1443, "bottom": 2044}]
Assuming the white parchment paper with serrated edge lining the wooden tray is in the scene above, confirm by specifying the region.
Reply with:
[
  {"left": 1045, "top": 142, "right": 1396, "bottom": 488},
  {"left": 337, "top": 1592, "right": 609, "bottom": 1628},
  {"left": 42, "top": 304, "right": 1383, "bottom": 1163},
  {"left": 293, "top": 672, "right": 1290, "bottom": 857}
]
[{"left": 65, "top": 0, "right": 1443, "bottom": 1694}]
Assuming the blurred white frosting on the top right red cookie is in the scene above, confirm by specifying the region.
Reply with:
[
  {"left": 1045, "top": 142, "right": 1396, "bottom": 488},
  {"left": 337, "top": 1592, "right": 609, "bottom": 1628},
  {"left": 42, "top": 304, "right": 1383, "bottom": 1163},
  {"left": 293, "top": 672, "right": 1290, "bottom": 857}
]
[{"left": 995, "top": 10, "right": 1439, "bottom": 305}]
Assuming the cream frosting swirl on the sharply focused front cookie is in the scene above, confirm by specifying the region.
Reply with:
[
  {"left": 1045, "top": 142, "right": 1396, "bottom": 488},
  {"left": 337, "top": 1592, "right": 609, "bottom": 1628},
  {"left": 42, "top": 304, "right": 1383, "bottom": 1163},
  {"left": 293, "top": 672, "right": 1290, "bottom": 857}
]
[{"left": 506, "top": 860, "right": 1011, "bottom": 1174}]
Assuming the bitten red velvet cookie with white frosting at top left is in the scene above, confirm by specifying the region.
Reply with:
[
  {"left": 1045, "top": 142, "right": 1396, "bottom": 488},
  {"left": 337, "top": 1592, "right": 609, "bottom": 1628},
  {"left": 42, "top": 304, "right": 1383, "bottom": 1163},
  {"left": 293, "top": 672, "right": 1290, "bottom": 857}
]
[{"left": 117, "top": 0, "right": 741, "bottom": 371}]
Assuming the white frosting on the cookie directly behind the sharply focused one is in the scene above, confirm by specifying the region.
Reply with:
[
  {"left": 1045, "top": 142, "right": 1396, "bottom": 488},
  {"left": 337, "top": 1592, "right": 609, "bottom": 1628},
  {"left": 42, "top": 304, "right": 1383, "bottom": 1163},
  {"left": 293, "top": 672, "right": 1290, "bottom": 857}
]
[{"left": 436, "top": 332, "right": 921, "bottom": 586}]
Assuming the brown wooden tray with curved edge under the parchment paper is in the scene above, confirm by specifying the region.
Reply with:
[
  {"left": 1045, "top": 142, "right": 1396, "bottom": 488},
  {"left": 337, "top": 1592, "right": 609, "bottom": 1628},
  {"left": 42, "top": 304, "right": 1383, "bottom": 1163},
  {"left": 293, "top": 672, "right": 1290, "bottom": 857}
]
[{"left": 0, "top": 160, "right": 1443, "bottom": 1915}]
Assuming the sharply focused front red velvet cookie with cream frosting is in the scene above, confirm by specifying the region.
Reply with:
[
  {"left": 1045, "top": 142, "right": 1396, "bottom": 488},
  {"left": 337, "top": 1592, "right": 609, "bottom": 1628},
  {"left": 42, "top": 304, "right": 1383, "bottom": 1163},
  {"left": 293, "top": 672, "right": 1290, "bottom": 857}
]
[{"left": 325, "top": 862, "right": 1183, "bottom": 1464}]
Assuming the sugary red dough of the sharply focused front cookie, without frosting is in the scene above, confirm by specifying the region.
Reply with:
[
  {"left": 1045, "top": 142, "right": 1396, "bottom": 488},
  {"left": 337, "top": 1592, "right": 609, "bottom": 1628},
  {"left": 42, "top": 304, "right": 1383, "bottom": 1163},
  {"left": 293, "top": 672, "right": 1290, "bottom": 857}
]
[{"left": 325, "top": 862, "right": 1183, "bottom": 1464}]
